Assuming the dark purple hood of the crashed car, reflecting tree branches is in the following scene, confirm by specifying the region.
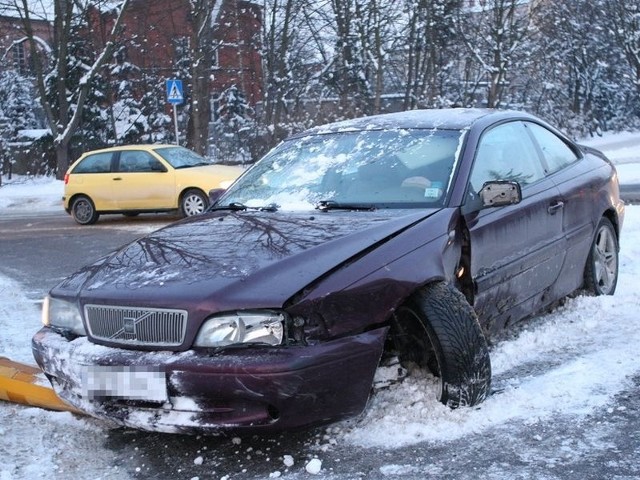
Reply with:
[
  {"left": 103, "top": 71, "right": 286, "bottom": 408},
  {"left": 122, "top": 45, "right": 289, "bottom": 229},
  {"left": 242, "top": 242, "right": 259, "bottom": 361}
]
[{"left": 52, "top": 209, "right": 437, "bottom": 312}]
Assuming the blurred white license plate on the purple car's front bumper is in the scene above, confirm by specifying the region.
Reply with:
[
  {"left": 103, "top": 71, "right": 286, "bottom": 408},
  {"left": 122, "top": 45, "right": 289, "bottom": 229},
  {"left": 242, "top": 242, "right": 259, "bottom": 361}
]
[{"left": 82, "top": 366, "right": 168, "bottom": 402}]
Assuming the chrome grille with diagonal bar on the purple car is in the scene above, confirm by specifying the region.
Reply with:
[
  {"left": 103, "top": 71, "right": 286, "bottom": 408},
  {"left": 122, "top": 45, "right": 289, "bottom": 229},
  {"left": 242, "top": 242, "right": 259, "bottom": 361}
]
[{"left": 84, "top": 305, "right": 187, "bottom": 347}]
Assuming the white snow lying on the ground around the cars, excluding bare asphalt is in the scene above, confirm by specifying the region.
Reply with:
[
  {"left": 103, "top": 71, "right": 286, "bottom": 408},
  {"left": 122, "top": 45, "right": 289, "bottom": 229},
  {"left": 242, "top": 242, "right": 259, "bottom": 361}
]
[{"left": 0, "top": 134, "right": 640, "bottom": 480}]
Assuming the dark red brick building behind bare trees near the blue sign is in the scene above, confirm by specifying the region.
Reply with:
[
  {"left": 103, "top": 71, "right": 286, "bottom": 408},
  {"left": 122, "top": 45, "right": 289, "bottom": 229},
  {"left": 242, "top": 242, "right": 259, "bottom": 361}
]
[{"left": 92, "top": 0, "right": 262, "bottom": 105}]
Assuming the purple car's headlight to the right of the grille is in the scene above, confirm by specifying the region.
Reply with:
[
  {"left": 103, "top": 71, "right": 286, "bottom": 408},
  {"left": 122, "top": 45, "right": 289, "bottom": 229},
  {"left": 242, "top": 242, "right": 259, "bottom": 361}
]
[{"left": 194, "top": 312, "right": 284, "bottom": 347}]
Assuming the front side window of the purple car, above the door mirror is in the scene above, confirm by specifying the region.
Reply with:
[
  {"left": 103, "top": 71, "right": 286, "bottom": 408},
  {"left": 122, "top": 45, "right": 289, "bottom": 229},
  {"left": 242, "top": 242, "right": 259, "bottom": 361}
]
[{"left": 470, "top": 122, "right": 544, "bottom": 192}]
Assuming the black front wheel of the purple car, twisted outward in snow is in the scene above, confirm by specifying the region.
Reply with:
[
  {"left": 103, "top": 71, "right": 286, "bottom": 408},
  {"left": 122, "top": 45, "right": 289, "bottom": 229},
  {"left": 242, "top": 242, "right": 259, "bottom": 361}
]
[{"left": 391, "top": 282, "right": 491, "bottom": 408}]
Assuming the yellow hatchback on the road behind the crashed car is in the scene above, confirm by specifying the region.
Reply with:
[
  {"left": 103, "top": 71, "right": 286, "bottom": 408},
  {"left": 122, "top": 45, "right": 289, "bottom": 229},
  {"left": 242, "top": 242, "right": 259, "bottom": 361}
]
[{"left": 63, "top": 145, "right": 244, "bottom": 225}]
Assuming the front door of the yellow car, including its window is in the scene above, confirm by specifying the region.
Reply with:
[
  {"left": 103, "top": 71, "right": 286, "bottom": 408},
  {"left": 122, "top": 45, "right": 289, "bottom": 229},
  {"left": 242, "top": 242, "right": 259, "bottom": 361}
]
[{"left": 113, "top": 150, "right": 176, "bottom": 210}]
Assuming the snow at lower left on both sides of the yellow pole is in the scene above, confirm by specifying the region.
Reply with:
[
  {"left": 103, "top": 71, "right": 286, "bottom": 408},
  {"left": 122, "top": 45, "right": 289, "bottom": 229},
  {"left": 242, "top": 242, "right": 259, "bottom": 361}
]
[{"left": 0, "top": 276, "right": 121, "bottom": 480}]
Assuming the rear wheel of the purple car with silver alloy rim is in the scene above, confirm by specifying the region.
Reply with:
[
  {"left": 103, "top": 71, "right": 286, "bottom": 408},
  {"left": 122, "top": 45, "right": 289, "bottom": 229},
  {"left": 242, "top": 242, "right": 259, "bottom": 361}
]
[{"left": 584, "top": 217, "right": 618, "bottom": 295}]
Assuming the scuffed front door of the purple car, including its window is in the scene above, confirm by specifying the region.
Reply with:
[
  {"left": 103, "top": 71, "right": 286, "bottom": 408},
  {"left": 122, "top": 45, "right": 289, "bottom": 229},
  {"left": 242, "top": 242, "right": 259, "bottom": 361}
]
[{"left": 463, "top": 121, "right": 566, "bottom": 329}]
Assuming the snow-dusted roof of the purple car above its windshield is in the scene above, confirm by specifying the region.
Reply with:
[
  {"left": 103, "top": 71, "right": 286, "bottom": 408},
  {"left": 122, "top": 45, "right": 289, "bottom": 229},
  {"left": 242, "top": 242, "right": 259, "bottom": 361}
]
[{"left": 292, "top": 108, "right": 534, "bottom": 138}]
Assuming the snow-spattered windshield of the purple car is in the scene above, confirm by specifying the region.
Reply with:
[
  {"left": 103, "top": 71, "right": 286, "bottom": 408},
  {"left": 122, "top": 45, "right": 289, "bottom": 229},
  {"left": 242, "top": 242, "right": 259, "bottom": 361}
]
[{"left": 217, "top": 129, "right": 462, "bottom": 210}]
